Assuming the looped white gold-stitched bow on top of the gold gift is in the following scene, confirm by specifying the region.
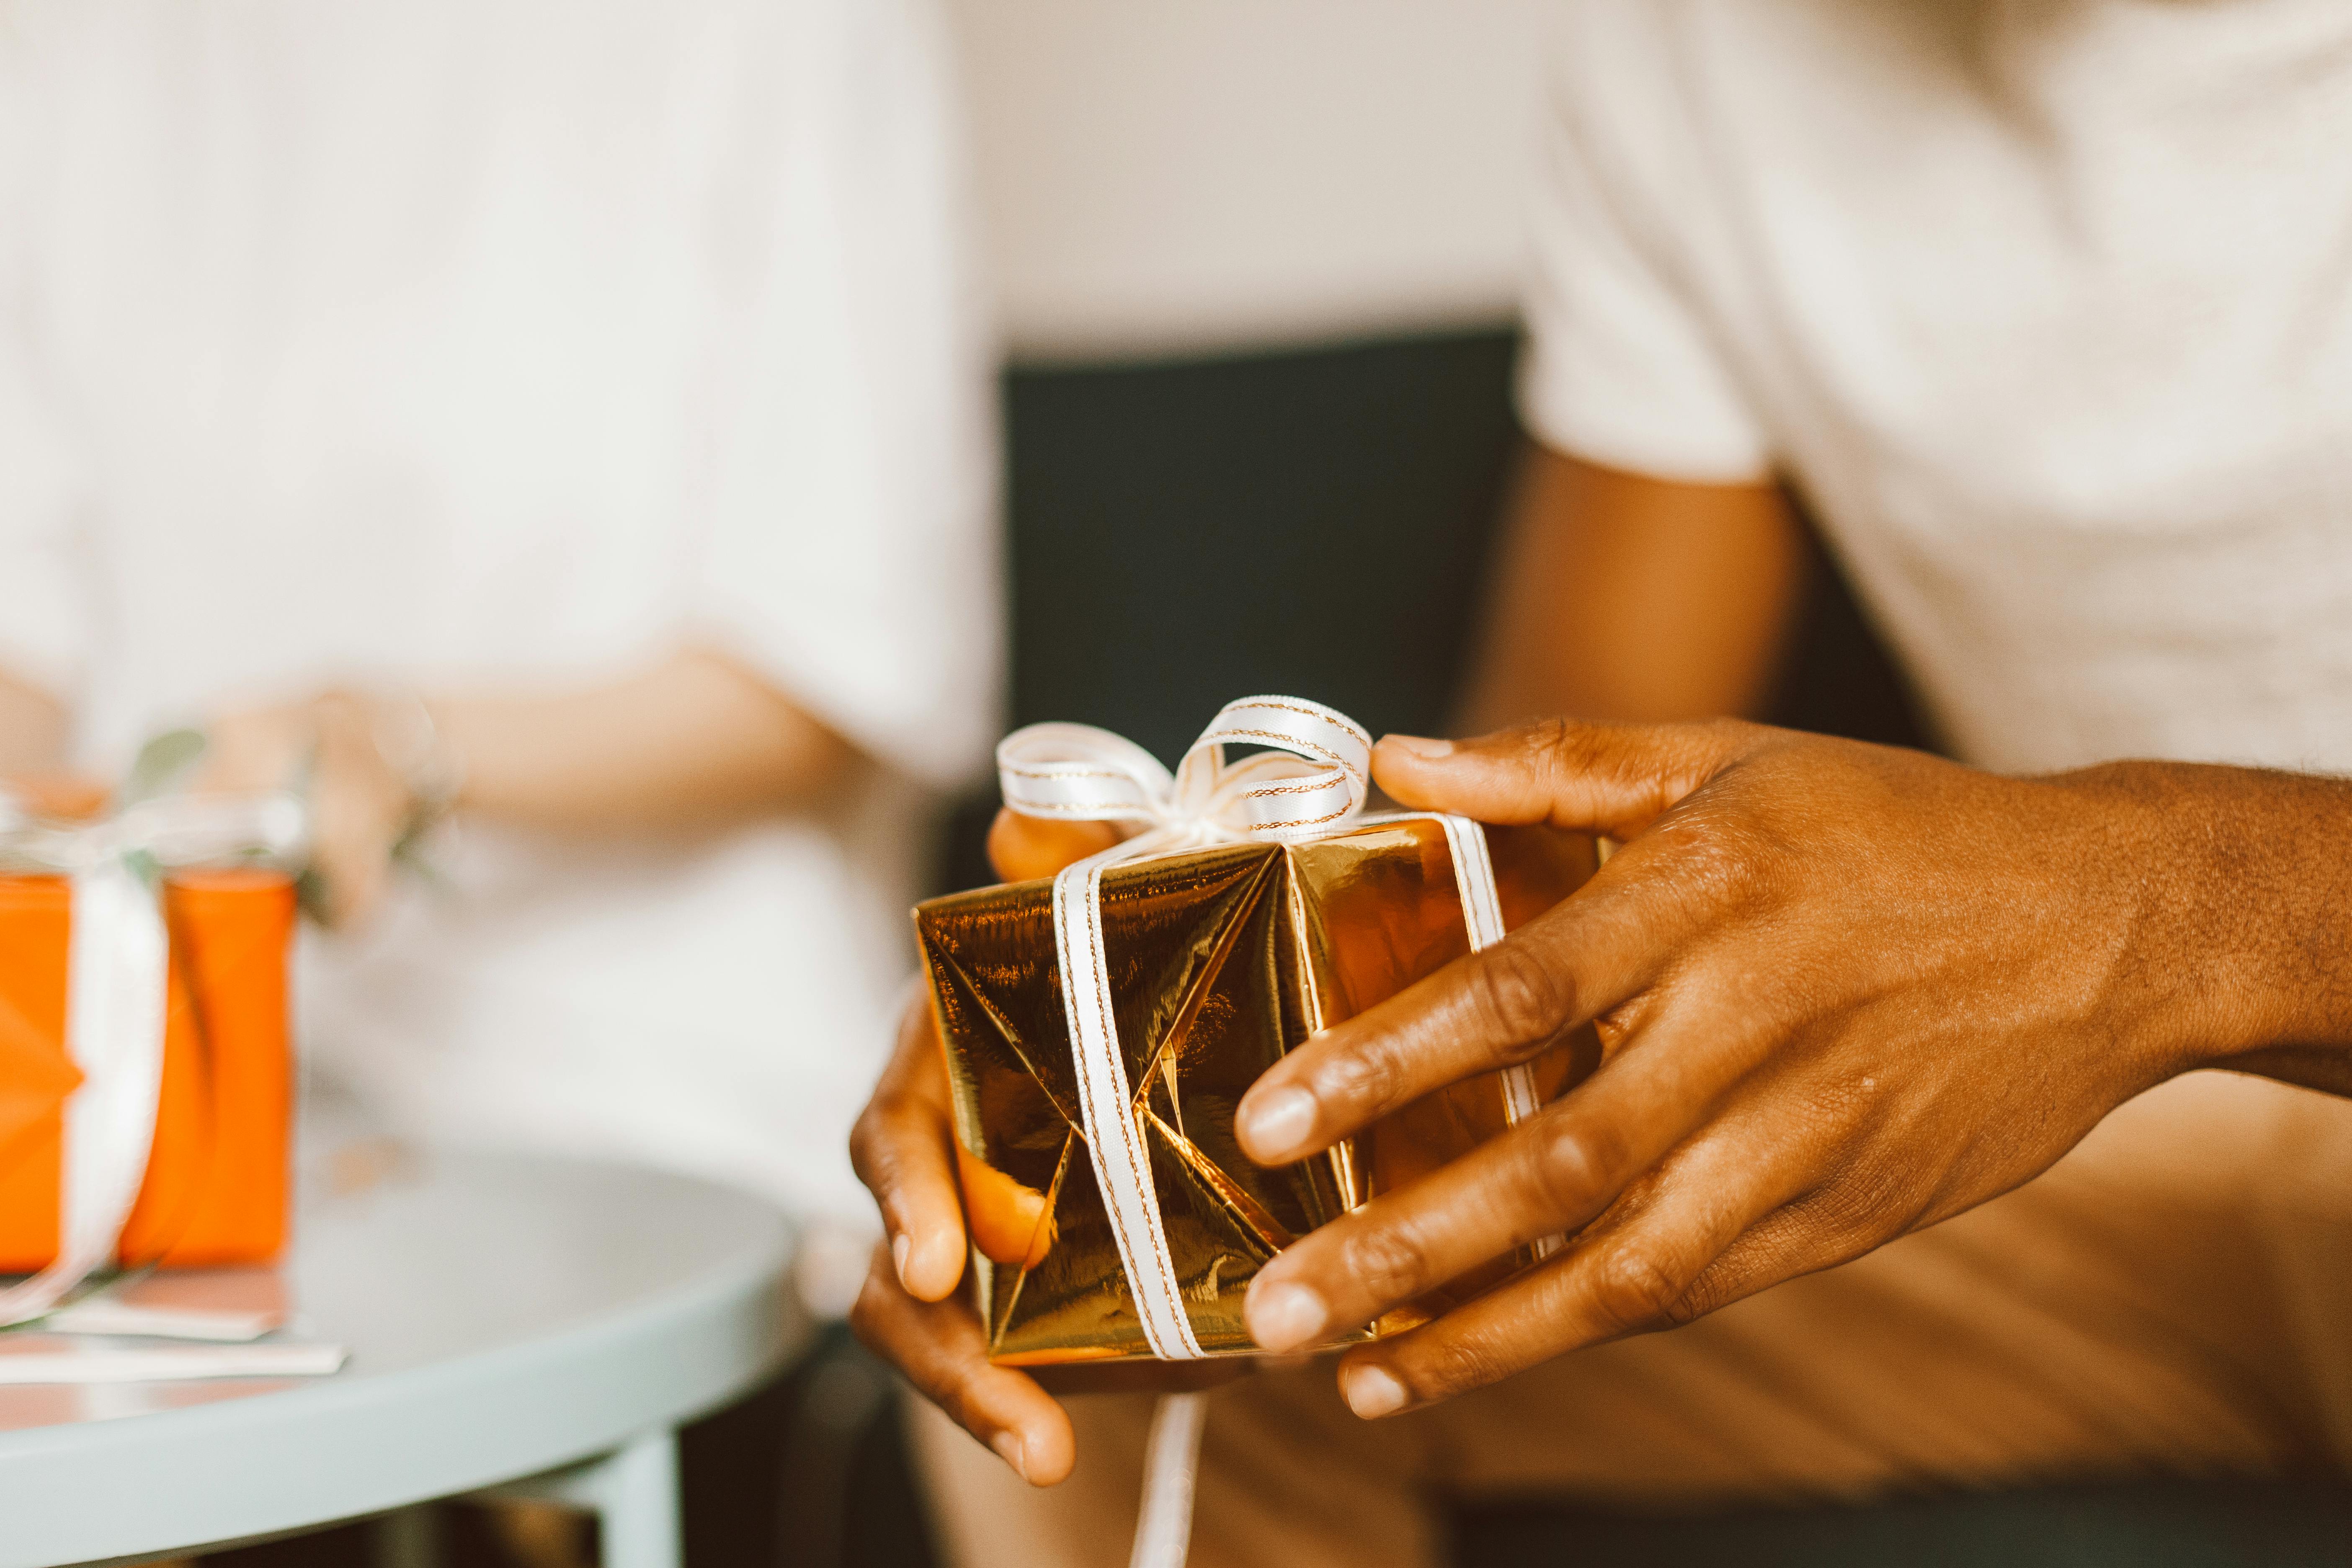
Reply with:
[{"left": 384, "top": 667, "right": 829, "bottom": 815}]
[{"left": 997, "top": 696, "right": 1371, "bottom": 858}]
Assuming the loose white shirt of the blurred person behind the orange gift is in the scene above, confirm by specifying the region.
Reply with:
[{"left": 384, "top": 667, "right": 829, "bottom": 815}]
[{"left": 0, "top": 0, "right": 1000, "bottom": 1218}]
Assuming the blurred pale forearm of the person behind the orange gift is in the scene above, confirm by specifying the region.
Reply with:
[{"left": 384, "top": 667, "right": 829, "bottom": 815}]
[{"left": 426, "top": 651, "right": 856, "bottom": 832}]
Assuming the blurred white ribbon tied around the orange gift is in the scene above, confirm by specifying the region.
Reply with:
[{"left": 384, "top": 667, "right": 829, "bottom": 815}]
[{"left": 0, "top": 794, "right": 308, "bottom": 1328}]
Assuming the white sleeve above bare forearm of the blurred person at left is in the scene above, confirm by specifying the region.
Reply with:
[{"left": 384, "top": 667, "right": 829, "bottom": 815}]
[{"left": 691, "top": 0, "right": 1002, "bottom": 785}]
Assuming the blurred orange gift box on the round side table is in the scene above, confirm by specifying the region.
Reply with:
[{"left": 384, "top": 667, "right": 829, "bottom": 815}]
[{"left": 0, "top": 867, "right": 294, "bottom": 1274}]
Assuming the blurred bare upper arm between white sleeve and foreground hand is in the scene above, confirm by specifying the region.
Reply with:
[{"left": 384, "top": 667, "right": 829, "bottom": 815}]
[{"left": 1461, "top": 447, "right": 1804, "bottom": 731}]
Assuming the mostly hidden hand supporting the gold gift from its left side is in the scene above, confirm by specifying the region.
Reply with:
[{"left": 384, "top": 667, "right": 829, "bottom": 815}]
[{"left": 849, "top": 811, "right": 1246, "bottom": 1486}]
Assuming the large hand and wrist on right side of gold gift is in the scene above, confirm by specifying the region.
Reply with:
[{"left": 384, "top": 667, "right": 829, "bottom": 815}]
[{"left": 1240, "top": 722, "right": 2352, "bottom": 1415}]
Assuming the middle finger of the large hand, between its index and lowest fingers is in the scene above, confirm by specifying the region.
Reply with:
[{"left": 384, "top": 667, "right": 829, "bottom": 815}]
[{"left": 1246, "top": 1016, "right": 1752, "bottom": 1352}]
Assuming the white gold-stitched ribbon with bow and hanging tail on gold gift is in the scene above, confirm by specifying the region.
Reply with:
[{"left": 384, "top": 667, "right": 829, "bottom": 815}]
[{"left": 997, "top": 696, "right": 1557, "bottom": 1568}]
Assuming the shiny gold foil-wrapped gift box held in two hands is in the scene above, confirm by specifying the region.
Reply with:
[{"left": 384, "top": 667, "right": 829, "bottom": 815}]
[{"left": 915, "top": 818, "right": 1599, "bottom": 1366}]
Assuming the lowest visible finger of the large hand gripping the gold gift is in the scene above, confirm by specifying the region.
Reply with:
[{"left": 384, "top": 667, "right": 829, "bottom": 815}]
[{"left": 1338, "top": 1138, "right": 1818, "bottom": 1420}]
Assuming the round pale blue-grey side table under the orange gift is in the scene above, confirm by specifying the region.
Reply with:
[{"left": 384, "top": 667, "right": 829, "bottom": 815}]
[{"left": 0, "top": 1150, "right": 809, "bottom": 1568}]
